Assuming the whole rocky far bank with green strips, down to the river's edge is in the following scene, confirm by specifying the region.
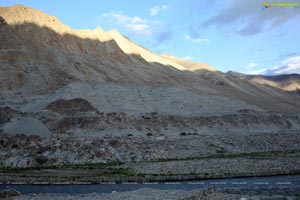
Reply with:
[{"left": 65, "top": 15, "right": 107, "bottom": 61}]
[{"left": 0, "top": 132, "right": 300, "bottom": 182}]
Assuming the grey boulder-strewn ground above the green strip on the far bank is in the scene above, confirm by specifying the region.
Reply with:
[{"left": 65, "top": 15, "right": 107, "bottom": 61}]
[{"left": 0, "top": 128, "right": 300, "bottom": 167}]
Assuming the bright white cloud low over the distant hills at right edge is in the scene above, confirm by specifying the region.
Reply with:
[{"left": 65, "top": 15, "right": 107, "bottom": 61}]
[{"left": 250, "top": 56, "right": 300, "bottom": 76}]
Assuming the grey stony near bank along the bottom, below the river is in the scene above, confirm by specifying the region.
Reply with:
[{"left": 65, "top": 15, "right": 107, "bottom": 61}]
[{"left": 1, "top": 188, "right": 297, "bottom": 200}]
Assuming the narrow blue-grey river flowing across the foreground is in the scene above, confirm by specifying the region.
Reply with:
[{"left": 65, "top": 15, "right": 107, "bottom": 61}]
[{"left": 0, "top": 175, "right": 300, "bottom": 194}]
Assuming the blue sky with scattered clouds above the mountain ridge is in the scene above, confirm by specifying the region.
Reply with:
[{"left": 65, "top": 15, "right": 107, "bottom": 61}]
[{"left": 0, "top": 0, "right": 300, "bottom": 75}]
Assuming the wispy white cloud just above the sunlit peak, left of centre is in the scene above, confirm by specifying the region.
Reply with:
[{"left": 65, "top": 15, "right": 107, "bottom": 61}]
[{"left": 98, "top": 11, "right": 152, "bottom": 35}]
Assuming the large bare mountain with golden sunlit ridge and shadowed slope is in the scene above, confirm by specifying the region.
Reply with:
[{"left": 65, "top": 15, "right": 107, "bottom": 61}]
[{"left": 0, "top": 5, "right": 299, "bottom": 111}]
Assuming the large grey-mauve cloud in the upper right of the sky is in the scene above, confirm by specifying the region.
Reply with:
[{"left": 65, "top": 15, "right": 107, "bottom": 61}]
[{"left": 202, "top": 0, "right": 300, "bottom": 35}]
